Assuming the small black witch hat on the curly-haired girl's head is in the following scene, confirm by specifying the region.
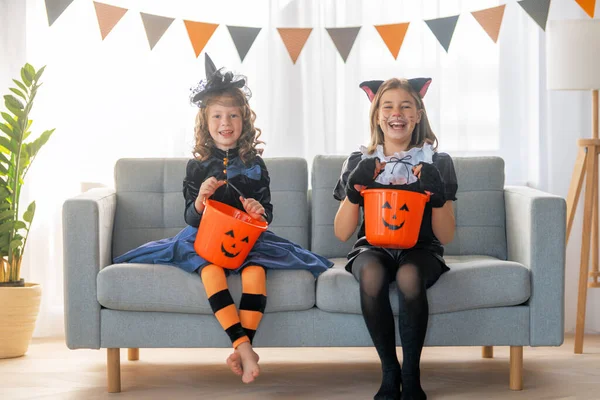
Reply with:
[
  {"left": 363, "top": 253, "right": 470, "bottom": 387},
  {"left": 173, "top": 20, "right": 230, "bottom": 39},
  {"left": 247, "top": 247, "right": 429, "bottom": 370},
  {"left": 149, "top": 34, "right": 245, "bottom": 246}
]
[{"left": 190, "top": 53, "right": 252, "bottom": 107}]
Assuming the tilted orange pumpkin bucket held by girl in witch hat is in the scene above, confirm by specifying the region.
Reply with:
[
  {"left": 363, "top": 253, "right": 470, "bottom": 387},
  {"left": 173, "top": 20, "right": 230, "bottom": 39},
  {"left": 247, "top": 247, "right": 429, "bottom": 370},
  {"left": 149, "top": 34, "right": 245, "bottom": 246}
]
[{"left": 194, "top": 200, "right": 268, "bottom": 269}]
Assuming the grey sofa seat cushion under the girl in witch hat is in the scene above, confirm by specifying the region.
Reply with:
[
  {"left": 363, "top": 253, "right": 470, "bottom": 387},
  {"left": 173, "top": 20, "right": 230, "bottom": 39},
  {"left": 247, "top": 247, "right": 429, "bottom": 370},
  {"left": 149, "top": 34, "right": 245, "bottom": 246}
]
[{"left": 97, "top": 264, "right": 315, "bottom": 314}]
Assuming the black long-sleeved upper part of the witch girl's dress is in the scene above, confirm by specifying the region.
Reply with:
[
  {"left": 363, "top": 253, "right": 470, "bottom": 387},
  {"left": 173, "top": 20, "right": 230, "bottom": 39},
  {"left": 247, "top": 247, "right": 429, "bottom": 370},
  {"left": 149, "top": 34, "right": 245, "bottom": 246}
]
[{"left": 183, "top": 147, "right": 273, "bottom": 227}]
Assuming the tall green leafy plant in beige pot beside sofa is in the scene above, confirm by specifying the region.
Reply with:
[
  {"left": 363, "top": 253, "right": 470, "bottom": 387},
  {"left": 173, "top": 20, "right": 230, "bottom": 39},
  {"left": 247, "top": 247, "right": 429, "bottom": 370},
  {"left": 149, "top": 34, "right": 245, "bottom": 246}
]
[{"left": 0, "top": 64, "right": 54, "bottom": 358}]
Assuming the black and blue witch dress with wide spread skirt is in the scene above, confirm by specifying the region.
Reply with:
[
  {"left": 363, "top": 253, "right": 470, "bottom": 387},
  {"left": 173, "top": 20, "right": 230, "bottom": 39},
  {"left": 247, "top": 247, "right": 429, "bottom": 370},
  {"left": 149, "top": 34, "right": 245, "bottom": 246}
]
[{"left": 113, "top": 148, "right": 333, "bottom": 275}]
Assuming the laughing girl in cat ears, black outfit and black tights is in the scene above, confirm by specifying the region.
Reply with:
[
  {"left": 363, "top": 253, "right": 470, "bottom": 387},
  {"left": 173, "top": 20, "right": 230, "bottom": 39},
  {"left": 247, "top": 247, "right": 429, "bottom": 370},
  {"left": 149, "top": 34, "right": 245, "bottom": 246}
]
[{"left": 333, "top": 78, "right": 458, "bottom": 400}]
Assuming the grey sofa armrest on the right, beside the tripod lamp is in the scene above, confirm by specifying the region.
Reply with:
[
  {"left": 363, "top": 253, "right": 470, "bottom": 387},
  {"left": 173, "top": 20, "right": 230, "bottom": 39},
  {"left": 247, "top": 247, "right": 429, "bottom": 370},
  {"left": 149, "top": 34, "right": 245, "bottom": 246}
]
[{"left": 504, "top": 186, "right": 566, "bottom": 346}]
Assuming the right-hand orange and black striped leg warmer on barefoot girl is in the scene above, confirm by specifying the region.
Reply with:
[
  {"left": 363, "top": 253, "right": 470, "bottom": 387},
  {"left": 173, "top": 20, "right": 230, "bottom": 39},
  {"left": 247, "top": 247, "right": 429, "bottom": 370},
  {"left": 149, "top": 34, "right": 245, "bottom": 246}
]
[{"left": 240, "top": 265, "right": 267, "bottom": 343}]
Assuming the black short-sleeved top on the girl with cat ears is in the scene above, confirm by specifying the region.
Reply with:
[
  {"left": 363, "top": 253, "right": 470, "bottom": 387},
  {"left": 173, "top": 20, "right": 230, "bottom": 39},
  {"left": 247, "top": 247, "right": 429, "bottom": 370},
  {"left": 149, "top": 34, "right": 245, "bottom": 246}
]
[{"left": 333, "top": 151, "right": 458, "bottom": 255}]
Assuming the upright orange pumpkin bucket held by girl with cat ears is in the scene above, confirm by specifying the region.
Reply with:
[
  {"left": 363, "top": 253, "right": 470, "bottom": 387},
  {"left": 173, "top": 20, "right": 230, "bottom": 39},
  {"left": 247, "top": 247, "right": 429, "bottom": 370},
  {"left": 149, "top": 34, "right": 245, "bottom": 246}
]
[{"left": 361, "top": 189, "right": 430, "bottom": 249}]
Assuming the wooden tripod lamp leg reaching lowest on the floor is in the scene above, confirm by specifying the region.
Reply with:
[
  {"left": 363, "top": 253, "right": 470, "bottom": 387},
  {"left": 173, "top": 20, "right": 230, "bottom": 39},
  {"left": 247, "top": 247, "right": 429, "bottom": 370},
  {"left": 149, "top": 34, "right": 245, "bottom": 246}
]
[{"left": 574, "top": 147, "right": 598, "bottom": 354}]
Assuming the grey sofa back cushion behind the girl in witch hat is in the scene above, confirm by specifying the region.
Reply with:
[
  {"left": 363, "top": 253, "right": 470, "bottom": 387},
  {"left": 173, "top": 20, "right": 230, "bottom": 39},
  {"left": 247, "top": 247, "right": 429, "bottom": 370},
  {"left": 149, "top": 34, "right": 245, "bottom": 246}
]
[{"left": 113, "top": 158, "right": 310, "bottom": 256}]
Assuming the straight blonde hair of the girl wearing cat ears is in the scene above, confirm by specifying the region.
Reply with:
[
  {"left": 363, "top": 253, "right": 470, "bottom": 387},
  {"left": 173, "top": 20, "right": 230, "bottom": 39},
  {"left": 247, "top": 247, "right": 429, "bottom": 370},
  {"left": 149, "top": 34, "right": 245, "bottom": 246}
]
[{"left": 367, "top": 78, "right": 438, "bottom": 154}]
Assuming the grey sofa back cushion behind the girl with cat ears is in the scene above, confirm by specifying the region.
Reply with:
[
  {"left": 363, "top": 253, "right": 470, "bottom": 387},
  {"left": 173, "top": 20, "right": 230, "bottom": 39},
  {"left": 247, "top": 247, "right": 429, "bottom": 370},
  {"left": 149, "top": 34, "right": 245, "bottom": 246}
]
[{"left": 311, "top": 156, "right": 506, "bottom": 259}]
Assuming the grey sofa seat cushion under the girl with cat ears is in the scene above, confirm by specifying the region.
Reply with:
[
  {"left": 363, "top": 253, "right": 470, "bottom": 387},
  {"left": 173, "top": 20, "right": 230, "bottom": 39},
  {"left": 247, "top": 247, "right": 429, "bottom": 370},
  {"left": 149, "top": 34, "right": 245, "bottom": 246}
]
[{"left": 317, "top": 256, "right": 531, "bottom": 315}]
